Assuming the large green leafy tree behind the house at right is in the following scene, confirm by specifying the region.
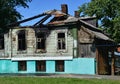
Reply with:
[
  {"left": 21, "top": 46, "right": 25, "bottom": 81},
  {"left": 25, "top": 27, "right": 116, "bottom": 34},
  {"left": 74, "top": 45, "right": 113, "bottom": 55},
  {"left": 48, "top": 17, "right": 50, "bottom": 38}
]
[{"left": 79, "top": 0, "right": 120, "bottom": 42}]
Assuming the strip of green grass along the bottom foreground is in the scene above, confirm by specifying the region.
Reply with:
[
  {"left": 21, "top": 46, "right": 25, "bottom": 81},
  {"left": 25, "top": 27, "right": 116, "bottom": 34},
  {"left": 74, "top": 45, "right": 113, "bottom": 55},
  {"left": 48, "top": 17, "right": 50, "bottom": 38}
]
[{"left": 0, "top": 77, "right": 120, "bottom": 84}]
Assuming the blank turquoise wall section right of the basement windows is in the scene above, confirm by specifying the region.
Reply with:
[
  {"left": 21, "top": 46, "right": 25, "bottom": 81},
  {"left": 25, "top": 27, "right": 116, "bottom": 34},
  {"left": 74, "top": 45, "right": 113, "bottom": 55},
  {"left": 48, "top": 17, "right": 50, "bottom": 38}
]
[{"left": 65, "top": 58, "right": 95, "bottom": 75}]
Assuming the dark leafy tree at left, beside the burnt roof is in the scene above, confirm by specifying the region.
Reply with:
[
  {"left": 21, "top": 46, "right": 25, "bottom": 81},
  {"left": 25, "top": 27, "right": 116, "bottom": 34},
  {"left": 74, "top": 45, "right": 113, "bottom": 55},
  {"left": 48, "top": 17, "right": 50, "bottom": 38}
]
[{"left": 0, "top": 0, "right": 31, "bottom": 33}]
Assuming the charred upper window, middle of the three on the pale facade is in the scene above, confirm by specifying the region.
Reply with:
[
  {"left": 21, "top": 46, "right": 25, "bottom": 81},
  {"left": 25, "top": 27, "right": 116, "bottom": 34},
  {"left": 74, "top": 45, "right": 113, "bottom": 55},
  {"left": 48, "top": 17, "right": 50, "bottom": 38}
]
[{"left": 36, "top": 32, "right": 46, "bottom": 50}]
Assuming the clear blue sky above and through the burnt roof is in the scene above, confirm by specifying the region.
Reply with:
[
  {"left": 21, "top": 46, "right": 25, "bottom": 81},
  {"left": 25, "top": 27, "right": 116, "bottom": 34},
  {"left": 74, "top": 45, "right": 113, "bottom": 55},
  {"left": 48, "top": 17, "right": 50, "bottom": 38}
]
[{"left": 17, "top": 0, "right": 90, "bottom": 26}]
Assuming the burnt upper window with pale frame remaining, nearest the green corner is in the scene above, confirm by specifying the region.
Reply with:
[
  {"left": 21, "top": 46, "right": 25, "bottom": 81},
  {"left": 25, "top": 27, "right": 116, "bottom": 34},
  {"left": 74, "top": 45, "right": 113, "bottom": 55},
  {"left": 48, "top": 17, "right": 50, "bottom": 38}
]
[{"left": 57, "top": 33, "right": 66, "bottom": 50}]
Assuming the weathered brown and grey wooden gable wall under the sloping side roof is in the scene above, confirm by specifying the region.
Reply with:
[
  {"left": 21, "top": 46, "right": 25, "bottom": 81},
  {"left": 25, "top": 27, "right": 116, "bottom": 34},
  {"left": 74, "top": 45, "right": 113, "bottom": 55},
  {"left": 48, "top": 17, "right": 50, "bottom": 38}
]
[{"left": 78, "top": 26, "right": 96, "bottom": 57}]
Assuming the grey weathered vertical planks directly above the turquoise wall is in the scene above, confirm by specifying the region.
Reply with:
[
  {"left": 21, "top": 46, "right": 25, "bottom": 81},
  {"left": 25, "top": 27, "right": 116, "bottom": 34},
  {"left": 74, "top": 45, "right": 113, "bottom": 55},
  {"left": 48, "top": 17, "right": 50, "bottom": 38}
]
[{"left": 79, "top": 43, "right": 96, "bottom": 57}]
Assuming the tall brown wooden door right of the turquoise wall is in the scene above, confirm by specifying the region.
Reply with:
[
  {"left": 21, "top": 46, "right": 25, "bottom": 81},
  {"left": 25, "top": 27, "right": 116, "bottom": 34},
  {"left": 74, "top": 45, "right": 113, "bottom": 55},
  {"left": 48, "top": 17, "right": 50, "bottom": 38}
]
[{"left": 96, "top": 47, "right": 111, "bottom": 75}]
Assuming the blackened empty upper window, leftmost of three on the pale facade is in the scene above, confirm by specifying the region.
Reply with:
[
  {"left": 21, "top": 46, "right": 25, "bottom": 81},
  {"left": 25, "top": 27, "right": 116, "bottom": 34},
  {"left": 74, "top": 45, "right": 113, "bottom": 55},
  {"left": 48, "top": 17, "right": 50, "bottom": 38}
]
[{"left": 18, "top": 30, "right": 26, "bottom": 50}]
